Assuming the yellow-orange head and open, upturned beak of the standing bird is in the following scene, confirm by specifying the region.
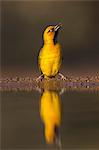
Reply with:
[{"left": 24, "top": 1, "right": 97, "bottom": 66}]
[{"left": 43, "top": 23, "right": 62, "bottom": 43}]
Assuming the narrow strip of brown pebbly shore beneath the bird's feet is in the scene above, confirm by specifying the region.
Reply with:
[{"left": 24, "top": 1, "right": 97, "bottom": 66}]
[{"left": 0, "top": 75, "right": 99, "bottom": 92}]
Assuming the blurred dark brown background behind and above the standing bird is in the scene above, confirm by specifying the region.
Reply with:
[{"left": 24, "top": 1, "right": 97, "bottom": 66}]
[{"left": 1, "top": 1, "right": 99, "bottom": 74}]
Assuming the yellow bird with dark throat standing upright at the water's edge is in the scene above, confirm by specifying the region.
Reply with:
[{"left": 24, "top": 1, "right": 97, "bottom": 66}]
[{"left": 36, "top": 23, "right": 66, "bottom": 81}]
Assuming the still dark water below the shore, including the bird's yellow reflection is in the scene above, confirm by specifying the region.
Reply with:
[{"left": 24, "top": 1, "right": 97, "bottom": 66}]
[{"left": 1, "top": 89, "right": 99, "bottom": 150}]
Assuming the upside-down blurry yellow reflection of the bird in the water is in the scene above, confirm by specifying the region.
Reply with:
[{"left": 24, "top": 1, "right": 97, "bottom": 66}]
[{"left": 40, "top": 89, "right": 61, "bottom": 146}]
